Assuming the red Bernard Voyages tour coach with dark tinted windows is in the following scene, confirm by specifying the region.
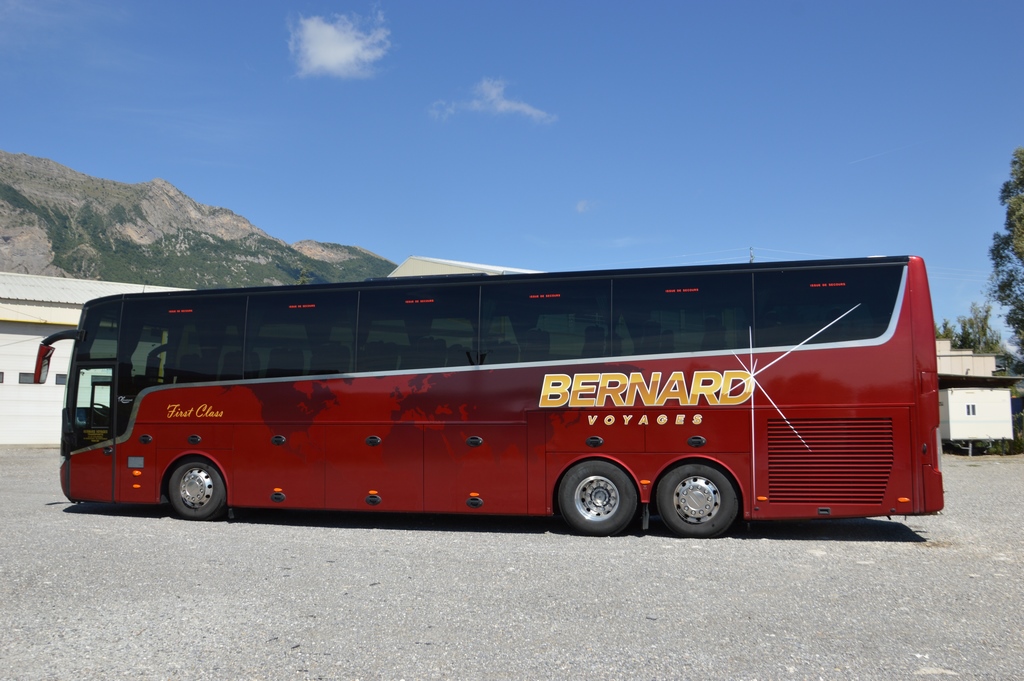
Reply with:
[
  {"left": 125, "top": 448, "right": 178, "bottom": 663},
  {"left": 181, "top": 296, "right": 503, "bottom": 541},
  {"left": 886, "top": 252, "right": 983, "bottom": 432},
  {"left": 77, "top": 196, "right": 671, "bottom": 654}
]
[{"left": 37, "top": 256, "right": 943, "bottom": 537}]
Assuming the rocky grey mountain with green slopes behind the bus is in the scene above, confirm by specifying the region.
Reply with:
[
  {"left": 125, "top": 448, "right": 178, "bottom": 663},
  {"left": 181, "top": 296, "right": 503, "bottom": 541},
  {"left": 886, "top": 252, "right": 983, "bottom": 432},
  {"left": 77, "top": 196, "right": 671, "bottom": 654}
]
[{"left": 0, "top": 152, "right": 395, "bottom": 289}]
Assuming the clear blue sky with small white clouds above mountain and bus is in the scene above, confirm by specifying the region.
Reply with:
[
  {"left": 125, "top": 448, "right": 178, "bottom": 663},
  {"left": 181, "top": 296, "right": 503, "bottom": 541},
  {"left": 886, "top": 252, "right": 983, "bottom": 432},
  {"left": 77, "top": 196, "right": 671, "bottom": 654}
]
[{"left": 0, "top": 0, "right": 1024, "bottom": 337}]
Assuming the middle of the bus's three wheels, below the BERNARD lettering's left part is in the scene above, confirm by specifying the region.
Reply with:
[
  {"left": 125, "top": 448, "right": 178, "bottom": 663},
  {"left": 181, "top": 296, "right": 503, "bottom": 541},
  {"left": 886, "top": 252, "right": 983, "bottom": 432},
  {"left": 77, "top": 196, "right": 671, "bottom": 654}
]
[{"left": 558, "top": 461, "right": 637, "bottom": 537}]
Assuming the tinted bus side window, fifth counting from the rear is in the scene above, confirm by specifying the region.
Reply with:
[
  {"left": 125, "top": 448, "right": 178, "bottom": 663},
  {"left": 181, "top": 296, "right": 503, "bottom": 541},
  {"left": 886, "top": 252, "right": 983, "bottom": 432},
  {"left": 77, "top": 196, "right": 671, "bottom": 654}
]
[{"left": 245, "top": 289, "right": 357, "bottom": 378}]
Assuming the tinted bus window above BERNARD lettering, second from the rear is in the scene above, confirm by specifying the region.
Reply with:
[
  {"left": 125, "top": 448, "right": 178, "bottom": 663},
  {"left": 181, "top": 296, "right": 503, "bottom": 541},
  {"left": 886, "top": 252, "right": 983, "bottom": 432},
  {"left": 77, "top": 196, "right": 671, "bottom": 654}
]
[{"left": 613, "top": 272, "right": 752, "bottom": 354}]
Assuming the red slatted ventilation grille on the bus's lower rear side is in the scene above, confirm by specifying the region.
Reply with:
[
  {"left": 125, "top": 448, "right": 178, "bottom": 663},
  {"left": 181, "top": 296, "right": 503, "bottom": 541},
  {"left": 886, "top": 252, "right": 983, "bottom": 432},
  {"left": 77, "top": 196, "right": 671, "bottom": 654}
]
[{"left": 768, "top": 419, "right": 893, "bottom": 505}]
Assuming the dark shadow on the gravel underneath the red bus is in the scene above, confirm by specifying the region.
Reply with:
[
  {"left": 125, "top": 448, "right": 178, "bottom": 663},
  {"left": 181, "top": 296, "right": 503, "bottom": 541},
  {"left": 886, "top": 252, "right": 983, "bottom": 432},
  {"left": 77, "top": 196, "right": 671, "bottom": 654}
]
[{"left": 63, "top": 502, "right": 929, "bottom": 544}]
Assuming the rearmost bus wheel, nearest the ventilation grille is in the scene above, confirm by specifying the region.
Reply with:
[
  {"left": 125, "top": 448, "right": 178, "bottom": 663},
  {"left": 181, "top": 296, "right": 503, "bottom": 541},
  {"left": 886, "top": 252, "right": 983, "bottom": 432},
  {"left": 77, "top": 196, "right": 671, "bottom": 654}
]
[{"left": 656, "top": 464, "right": 739, "bottom": 539}]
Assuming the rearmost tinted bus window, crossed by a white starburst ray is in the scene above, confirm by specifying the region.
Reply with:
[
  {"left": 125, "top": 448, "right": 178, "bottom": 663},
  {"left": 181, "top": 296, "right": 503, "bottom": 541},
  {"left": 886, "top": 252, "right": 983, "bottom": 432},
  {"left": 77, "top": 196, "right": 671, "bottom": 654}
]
[{"left": 754, "top": 265, "right": 903, "bottom": 347}]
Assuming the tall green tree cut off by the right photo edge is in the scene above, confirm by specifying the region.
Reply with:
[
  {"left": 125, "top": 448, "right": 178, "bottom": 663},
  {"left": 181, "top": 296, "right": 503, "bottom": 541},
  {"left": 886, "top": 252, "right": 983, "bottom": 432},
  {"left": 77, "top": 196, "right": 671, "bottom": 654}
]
[{"left": 988, "top": 146, "right": 1024, "bottom": 367}]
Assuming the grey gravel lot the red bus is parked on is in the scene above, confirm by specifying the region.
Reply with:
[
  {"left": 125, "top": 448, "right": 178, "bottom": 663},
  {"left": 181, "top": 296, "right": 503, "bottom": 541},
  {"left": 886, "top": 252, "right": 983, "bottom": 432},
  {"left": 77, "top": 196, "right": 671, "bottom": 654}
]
[{"left": 0, "top": 448, "right": 1024, "bottom": 680}]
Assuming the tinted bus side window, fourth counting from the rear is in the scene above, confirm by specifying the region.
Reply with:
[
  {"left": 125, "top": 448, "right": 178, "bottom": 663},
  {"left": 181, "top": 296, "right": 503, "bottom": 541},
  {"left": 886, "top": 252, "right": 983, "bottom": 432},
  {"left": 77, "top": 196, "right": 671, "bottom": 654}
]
[{"left": 356, "top": 285, "right": 479, "bottom": 372}]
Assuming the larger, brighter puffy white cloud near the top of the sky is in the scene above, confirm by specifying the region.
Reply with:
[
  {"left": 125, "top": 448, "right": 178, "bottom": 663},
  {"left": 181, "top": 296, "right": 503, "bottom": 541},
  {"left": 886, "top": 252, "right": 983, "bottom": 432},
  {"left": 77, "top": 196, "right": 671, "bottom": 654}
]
[{"left": 288, "top": 13, "right": 391, "bottom": 78}]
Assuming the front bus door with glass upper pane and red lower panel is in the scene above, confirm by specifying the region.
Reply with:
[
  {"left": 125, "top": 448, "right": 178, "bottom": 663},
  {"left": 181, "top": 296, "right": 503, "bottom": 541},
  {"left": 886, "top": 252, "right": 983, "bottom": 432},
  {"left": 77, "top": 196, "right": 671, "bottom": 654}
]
[{"left": 63, "top": 363, "right": 117, "bottom": 502}]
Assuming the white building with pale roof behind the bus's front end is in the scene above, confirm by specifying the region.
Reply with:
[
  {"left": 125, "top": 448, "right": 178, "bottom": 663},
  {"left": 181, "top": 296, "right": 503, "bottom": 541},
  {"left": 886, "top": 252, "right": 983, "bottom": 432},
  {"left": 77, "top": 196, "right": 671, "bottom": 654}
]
[{"left": 0, "top": 272, "right": 181, "bottom": 446}]
